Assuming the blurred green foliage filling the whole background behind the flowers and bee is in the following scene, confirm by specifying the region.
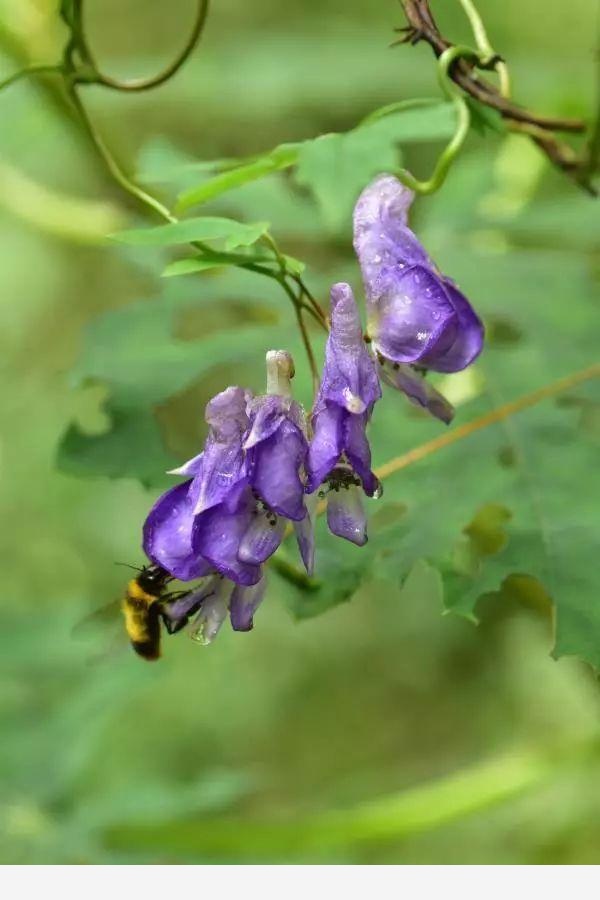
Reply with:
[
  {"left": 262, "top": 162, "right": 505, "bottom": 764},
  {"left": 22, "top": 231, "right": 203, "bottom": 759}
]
[{"left": 0, "top": 0, "right": 600, "bottom": 863}]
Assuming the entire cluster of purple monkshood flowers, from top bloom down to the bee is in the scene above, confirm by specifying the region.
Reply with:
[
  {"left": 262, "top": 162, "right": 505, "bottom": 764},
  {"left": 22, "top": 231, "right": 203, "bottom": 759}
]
[{"left": 144, "top": 175, "right": 483, "bottom": 642}]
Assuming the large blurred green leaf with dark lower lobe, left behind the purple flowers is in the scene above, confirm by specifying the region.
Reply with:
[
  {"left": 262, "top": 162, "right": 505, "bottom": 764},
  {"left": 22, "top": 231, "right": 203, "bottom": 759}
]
[{"left": 57, "top": 276, "right": 286, "bottom": 485}]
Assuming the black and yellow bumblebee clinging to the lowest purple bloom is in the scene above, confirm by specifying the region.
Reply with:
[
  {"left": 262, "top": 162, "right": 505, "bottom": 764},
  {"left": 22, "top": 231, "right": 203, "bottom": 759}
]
[{"left": 121, "top": 566, "right": 173, "bottom": 660}]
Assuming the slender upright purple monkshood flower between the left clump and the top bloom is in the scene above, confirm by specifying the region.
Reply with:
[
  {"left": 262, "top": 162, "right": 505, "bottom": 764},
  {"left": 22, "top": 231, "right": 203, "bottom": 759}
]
[{"left": 306, "top": 284, "right": 381, "bottom": 546}]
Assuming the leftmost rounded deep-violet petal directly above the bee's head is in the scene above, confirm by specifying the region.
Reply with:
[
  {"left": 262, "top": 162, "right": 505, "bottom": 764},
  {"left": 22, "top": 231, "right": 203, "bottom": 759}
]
[{"left": 143, "top": 481, "right": 211, "bottom": 581}]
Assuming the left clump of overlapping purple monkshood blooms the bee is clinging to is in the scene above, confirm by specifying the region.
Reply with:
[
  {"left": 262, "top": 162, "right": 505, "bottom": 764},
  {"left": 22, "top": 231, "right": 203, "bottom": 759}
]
[{"left": 143, "top": 351, "right": 313, "bottom": 639}]
